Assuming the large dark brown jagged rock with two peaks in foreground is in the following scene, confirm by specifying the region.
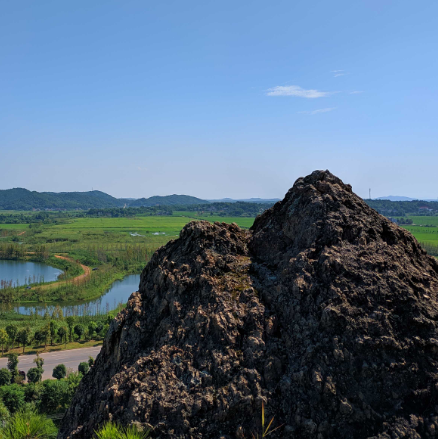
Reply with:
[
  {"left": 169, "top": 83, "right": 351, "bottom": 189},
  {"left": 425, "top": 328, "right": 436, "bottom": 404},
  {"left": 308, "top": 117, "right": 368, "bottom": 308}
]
[{"left": 58, "top": 171, "right": 438, "bottom": 439}]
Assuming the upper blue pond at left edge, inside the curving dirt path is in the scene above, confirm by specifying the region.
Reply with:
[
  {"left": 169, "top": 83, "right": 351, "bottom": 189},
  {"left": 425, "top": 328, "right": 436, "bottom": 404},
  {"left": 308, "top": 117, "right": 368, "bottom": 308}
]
[{"left": 0, "top": 260, "right": 62, "bottom": 286}]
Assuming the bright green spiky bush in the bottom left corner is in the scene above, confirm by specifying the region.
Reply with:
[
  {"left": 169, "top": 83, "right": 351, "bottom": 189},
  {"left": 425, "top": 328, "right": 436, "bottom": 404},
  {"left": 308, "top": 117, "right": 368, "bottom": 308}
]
[{"left": 1, "top": 410, "right": 57, "bottom": 439}]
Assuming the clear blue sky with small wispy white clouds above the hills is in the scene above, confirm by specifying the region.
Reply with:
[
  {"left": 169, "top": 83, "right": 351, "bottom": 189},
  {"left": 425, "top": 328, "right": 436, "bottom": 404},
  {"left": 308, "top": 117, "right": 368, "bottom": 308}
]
[{"left": 0, "top": 0, "right": 438, "bottom": 198}]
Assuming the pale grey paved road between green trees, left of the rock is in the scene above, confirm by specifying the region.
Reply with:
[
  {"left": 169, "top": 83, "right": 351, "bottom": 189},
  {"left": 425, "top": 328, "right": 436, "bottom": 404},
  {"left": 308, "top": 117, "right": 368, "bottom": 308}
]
[{"left": 0, "top": 346, "right": 101, "bottom": 380}]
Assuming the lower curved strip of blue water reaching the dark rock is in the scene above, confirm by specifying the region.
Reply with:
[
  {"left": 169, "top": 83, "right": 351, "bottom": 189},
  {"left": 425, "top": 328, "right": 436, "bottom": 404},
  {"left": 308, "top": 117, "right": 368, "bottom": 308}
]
[{"left": 2, "top": 274, "right": 140, "bottom": 316}]
